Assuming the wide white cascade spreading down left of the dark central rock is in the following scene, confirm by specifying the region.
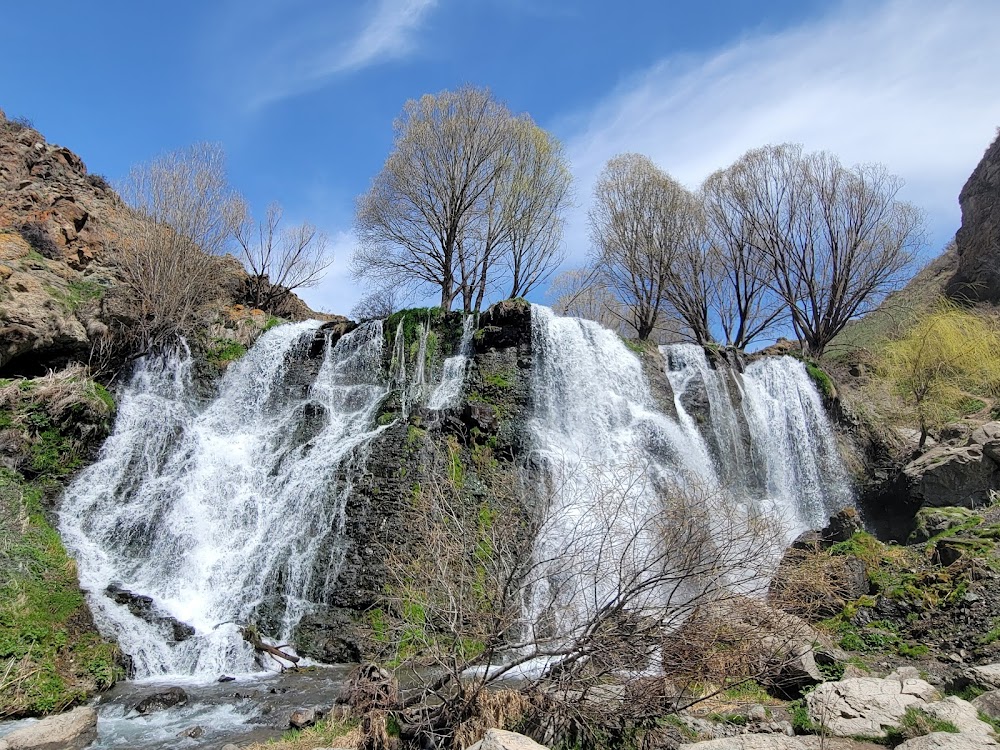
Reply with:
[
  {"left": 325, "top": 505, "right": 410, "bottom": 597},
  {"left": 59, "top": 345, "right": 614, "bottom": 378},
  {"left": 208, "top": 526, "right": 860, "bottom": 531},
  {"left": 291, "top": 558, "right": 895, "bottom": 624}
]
[{"left": 60, "top": 321, "right": 386, "bottom": 677}]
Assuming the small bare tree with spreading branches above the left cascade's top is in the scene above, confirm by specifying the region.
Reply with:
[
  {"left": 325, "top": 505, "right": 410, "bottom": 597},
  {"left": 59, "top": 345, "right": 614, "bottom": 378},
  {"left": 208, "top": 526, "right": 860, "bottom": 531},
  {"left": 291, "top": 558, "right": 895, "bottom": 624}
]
[{"left": 232, "top": 203, "right": 333, "bottom": 311}]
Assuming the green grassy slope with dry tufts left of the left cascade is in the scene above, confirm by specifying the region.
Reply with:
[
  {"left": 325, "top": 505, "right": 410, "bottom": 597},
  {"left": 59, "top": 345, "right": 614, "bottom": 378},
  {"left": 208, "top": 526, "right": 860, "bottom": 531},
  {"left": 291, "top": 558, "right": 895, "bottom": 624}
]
[{"left": 0, "top": 369, "right": 122, "bottom": 718}]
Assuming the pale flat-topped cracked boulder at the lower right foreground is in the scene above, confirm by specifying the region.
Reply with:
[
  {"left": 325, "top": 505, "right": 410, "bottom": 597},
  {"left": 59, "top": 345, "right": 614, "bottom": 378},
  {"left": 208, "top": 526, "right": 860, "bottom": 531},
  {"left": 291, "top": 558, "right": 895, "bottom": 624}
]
[{"left": 806, "top": 677, "right": 935, "bottom": 737}]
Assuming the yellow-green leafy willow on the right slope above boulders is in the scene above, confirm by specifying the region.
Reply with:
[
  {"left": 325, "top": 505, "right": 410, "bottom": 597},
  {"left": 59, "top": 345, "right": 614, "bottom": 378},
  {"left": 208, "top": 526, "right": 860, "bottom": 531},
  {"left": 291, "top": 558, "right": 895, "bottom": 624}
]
[{"left": 879, "top": 301, "right": 1000, "bottom": 448}]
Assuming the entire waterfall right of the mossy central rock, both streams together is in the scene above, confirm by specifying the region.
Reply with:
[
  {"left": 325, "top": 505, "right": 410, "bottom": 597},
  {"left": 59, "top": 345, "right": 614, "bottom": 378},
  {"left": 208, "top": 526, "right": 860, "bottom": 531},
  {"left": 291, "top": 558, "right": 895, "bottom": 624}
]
[{"left": 525, "top": 306, "right": 850, "bottom": 644}]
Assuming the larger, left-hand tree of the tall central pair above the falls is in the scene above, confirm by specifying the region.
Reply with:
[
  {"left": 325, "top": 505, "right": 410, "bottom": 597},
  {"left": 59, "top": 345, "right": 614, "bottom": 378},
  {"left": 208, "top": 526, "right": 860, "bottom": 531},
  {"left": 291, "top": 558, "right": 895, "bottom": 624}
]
[{"left": 354, "top": 87, "right": 510, "bottom": 310}]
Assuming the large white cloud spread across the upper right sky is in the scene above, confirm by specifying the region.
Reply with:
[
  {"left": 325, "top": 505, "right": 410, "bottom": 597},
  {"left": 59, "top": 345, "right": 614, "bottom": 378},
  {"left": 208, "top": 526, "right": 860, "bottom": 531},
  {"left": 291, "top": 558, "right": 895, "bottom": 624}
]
[{"left": 555, "top": 0, "right": 1000, "bottom": 264}]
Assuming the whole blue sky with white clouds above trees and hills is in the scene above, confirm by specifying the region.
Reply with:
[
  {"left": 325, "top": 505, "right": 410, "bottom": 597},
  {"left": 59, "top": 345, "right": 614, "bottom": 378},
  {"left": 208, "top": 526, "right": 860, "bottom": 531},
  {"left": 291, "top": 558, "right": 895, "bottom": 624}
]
[{"left": 0, "top": 0, "right": 1000, "bottom": 313}]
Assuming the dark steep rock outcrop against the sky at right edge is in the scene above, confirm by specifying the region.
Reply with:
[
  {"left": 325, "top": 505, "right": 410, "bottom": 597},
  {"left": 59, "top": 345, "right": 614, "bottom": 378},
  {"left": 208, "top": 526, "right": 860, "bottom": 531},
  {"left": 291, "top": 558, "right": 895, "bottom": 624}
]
[{"left": 947, "top": 131, "right": 1000, "bottom": 304}]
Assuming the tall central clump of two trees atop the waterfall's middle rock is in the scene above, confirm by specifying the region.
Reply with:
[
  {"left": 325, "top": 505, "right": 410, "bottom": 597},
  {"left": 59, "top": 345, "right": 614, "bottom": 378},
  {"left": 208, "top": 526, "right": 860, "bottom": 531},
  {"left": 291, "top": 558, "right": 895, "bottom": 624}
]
[{"left": 353, "top": 87, "right": 569, "bottom": 311}]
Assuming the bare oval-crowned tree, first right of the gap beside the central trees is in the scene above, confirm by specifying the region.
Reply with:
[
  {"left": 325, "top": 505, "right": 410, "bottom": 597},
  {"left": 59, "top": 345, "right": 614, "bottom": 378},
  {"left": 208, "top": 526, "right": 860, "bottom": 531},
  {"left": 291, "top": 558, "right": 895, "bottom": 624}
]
[{"left": 589, "top": 154, "right": 687, "bottom": 340}]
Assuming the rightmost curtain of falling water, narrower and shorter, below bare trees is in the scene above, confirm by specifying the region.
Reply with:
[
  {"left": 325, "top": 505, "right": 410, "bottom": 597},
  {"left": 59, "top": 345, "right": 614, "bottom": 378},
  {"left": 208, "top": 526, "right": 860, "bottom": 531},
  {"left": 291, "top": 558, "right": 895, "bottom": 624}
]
[{"left": 661, "top": 344, "right": 851, "bottom": 536}]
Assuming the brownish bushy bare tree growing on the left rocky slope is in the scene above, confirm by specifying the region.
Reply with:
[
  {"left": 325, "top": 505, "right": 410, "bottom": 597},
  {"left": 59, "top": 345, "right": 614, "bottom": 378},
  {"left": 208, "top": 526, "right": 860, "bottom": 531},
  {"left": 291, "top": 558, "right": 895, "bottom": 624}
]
[{"left": 116, "top": 144, "right": 237, "bottom": 353}]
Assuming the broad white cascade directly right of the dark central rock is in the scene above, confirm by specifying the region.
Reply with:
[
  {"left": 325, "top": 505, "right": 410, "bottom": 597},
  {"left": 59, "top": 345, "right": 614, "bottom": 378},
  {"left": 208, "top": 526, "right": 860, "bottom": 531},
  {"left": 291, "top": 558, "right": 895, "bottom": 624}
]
[{"left": 528, "top": 305, "right": 718, "bottom": 633}]
